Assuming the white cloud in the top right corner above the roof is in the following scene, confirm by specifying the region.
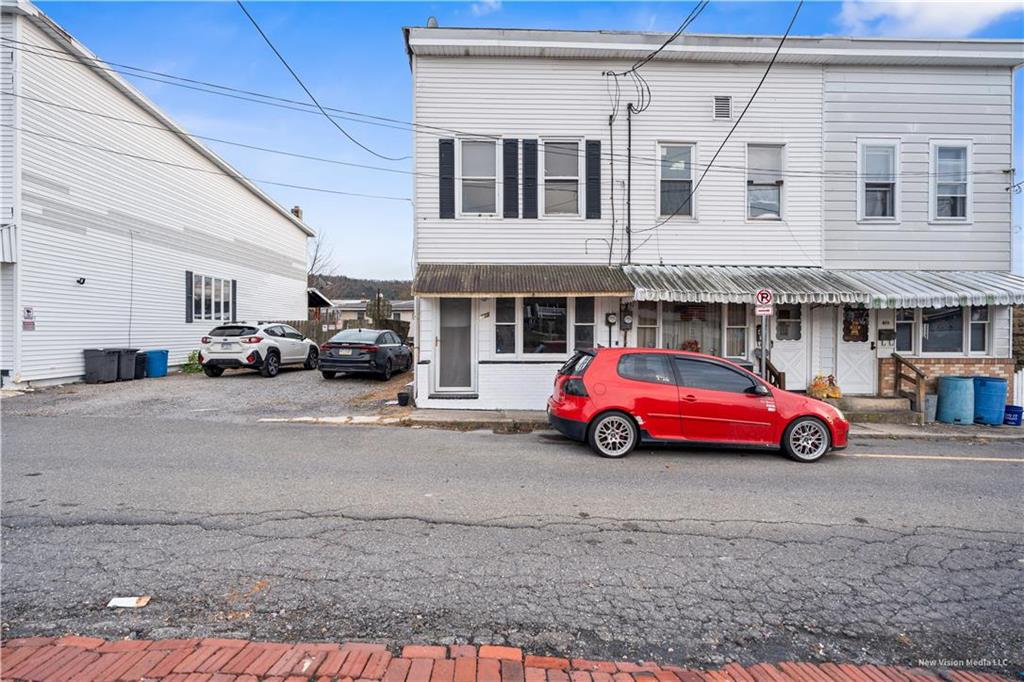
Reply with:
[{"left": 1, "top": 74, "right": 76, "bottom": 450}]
[{"left": 839, "top": 0, "right": 1021, "bottom": 38}]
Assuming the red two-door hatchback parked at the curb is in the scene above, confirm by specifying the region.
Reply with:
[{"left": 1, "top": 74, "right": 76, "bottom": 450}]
[{"left": 548, "top": 348, "right": 850, "bottom": 462}]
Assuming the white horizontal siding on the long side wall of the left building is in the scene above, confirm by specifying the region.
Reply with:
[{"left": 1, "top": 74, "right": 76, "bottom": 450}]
[{"left": 17, "top": 20, "right": 306, "bottom": 381}]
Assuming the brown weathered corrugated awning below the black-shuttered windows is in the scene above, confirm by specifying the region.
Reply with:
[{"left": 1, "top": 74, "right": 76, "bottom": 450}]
[{"left": 413, "top": 263, "right": 633, "bottom": 297}]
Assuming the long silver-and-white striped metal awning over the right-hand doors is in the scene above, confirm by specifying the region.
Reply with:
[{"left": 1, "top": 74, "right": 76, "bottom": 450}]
[{"left": 624, "top": 265, "right": 1024, "bottom": 308}]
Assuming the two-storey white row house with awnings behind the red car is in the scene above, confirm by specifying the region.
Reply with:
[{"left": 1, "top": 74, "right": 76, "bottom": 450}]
[{"left": 406, "top": 27, "right": 1024, "bottom": 409}]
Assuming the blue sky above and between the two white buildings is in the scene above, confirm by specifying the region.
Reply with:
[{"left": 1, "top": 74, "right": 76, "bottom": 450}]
[{"left": 39, "top": 0, "right": 1024, "bottom": 278}]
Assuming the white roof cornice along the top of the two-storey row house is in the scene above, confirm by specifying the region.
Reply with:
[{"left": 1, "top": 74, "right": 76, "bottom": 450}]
[{"left": 403, "top": 27, "right": 1024, "bottom": 67}]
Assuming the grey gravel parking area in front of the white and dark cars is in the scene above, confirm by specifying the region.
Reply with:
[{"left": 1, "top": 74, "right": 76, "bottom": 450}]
[{"left": 0, "top": 368, "right": 413, "bottom": 422}]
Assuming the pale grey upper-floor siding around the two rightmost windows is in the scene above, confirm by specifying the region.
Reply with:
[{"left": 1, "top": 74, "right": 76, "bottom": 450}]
[{"left": 824, "top": 67, "right": 1012, "bottom": 270}]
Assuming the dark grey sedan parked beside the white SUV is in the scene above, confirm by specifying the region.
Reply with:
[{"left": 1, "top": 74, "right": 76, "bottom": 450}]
[{"left": 319, "top": 329, "right": 413, "bottom": 381}]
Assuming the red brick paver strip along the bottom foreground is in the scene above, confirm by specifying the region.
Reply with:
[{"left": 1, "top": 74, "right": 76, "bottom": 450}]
[{"left": 0, "top": 637, "right": 1006, "bottom": 682}]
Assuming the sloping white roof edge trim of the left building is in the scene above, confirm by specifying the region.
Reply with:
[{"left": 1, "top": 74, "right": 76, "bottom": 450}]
[{"left": 0, "top": 0, "right": 316, "bottom": 237}]
